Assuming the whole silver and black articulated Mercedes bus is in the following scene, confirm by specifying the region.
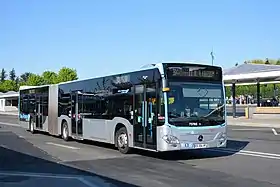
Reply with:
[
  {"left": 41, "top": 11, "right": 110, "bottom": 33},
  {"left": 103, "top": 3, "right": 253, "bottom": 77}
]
[{"left": 19, "top": 62, "right": 227, "bottom": 154}]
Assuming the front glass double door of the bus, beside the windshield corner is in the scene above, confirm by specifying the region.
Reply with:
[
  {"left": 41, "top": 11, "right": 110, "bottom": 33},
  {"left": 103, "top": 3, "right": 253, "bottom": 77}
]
[{"left": 133, "top": 85, "right": 157, "bottom": 150}]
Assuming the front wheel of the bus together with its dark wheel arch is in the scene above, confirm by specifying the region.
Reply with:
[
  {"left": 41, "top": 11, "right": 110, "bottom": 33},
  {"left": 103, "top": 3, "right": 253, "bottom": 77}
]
[{"left": 114, "top": 123, "right": 131, "bottom": 154}]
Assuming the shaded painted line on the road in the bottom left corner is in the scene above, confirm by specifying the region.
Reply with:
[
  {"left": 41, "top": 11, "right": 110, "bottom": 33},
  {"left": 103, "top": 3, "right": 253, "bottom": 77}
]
[{"left": 0, "top": 171, "right": 98, "bottom": 187}]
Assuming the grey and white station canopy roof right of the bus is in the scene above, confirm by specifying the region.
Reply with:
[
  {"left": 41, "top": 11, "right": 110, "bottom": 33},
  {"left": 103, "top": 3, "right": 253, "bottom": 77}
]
[{"left": 224, "top": 64, "right": 280, "bottom": 86}]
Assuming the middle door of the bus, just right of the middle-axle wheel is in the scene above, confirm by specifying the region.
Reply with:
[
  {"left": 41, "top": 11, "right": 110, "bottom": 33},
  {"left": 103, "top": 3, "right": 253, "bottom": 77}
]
[{"left": 71, "top": 92, "right": 83, "bottom": 137}]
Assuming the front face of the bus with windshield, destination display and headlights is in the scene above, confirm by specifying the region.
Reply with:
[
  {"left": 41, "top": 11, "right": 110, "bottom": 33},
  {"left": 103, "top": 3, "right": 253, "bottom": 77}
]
[{"left": 158, "top": 64, "right": 227, "bottom": 151}]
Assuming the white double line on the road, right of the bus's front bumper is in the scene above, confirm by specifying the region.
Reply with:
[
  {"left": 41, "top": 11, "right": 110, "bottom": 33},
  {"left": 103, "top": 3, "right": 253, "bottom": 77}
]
[{"left": 209, "top": 149, "right": 280, "bottom": 160}]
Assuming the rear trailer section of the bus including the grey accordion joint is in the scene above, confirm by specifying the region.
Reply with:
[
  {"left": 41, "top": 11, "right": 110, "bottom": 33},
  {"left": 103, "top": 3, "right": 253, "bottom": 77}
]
[{"left": 18, "top": 85, "right": 60, "bottom": 135}]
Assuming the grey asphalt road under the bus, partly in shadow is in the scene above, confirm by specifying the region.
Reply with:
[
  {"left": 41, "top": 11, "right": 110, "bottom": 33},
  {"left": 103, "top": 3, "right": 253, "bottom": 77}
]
[{"left": 0, "top": 115, "right": 280, "bottom": 187}]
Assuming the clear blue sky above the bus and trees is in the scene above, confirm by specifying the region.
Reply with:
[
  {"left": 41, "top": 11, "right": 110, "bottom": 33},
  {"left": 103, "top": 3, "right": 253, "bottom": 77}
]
[{"left": 0, "top": 0, "right": 280, "bottom": 79}]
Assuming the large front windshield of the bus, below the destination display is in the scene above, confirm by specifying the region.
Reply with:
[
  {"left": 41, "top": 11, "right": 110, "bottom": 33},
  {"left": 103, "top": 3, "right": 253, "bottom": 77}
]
[{"left": 168, "top": 82, "right": 225, "bottom": 126}]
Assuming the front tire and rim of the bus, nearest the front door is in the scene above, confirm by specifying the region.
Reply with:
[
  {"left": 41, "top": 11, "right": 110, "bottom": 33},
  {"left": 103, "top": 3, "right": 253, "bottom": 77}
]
[{"left": 116, "top": 127, "right": 130, "bottom": 154}]
